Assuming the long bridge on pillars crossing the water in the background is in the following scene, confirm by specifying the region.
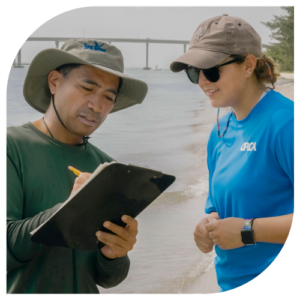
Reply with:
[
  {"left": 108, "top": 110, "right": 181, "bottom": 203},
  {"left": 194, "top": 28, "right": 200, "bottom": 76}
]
[{"left": 13, "top": 37, "right": 190, "bottom": 70}]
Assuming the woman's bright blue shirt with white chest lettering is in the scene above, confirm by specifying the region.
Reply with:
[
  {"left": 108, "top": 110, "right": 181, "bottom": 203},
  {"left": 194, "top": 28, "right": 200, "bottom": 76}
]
[{"left": 205, "top": 90, "right": 295, "bottom": 292}]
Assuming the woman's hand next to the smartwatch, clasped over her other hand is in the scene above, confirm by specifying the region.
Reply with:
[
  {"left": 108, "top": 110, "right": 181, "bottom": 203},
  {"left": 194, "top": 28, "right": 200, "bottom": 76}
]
[{"left": 205, "top": 218, "right": 245, "bottom": 250}]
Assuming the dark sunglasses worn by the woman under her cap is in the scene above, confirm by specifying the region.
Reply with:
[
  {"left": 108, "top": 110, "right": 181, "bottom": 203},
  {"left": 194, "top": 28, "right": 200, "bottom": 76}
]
[{"left": 184, "top": 59, "right": 239, "bottom": 84}]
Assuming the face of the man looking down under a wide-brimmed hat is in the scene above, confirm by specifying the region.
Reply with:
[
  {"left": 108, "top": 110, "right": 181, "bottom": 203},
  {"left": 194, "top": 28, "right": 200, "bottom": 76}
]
[{"left": 49, "top": 65, "right": 120, "bottom": 137}]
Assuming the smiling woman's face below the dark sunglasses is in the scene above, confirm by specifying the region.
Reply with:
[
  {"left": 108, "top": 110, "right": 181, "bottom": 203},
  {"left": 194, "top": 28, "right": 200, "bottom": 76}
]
[{"left": 199, "top": 57, "right": 248, "bottom": 108}]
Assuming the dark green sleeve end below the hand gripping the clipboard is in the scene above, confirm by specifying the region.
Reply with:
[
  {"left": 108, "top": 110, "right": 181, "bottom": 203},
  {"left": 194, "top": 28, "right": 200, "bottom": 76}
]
[{"left": 95, "top": 251, "right": 130, "bottom": 289}]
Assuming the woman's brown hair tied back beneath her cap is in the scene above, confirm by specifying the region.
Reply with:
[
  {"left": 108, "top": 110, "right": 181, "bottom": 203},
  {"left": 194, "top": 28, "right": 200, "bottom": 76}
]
[{"left": 230, "top": 55, "right": 280, "bottom": 84}]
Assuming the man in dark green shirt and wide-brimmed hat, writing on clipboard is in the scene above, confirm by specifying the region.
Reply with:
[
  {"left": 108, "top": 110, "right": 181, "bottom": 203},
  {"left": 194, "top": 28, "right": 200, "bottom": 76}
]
[{"left": 5, "top": 39, "right": 148, "bottom": 295}]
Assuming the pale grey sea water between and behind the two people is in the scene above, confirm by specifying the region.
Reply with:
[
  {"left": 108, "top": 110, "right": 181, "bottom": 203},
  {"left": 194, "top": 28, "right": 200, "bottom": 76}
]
[{"left": 5, "top": 67, "right": 292, "bottom": 295}]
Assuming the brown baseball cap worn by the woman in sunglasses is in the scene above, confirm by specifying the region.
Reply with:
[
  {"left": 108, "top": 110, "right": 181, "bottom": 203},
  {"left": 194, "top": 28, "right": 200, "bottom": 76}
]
[{"left": 170, "top": 14, "right": 263, "bottom": 72}]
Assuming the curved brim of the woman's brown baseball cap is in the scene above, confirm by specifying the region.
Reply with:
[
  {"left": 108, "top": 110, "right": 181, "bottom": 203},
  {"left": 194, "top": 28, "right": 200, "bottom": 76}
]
[{"left": 170, "top": 49, "right": 230, "bottom": 73}]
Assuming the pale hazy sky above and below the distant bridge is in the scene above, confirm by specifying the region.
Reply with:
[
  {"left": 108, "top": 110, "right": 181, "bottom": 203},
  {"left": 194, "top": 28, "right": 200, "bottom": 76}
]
[{"left": 16, "top": 5, "right": 284, "bottom": 69}]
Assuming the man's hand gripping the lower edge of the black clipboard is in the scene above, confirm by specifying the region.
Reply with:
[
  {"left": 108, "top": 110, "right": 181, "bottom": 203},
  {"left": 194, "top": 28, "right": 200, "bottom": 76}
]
[{"left": 96, "top": 216, "right": 138, "bottom": 259}]
